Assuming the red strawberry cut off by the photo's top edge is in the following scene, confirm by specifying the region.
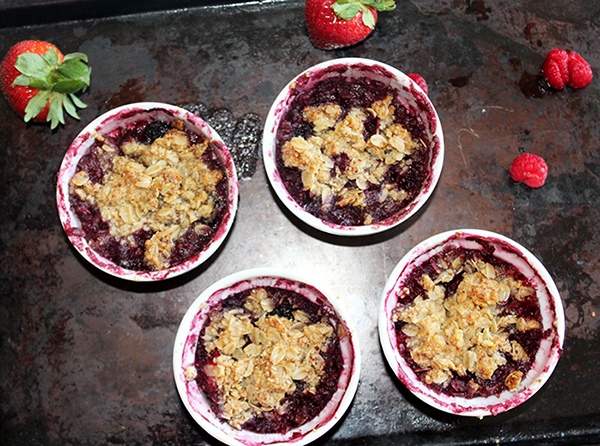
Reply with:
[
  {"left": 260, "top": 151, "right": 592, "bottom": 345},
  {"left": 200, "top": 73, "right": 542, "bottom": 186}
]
[{"left": 304, "top": 0, "right": 396, "bottom": 50}]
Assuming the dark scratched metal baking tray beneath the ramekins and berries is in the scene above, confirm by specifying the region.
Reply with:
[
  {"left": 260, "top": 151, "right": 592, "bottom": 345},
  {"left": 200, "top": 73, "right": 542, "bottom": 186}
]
[{"left": 0, "top": 0, "right": 600, "bottom": 446}]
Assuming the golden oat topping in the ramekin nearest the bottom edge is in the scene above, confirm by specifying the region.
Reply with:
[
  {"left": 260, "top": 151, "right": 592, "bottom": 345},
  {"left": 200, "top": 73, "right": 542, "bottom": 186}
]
[{"left": 199, "top": 288, "right": 334, "bottom": 428}]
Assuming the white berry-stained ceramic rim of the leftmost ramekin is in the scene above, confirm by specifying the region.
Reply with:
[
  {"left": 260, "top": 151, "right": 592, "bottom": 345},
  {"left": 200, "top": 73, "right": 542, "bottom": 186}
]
[{"left": 56, "top": 102, "right": 239, "bottom": 282}]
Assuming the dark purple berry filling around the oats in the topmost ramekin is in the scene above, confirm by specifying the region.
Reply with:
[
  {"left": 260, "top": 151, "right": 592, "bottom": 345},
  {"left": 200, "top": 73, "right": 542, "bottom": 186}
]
[{"left": 275, "top": 66, "right": 434, "bottom": 226}]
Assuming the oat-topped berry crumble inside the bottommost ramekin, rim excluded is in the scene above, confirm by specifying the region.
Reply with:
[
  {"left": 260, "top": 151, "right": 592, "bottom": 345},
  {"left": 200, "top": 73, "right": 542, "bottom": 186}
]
[{"left": 184, "top": 286, "right": 347, "bottom": 434}]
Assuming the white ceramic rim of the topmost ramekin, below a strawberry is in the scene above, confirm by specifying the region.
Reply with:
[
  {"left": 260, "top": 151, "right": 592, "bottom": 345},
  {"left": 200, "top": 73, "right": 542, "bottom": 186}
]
[{"left": 263, "top": 57, "right": 444, "bottom": 236}]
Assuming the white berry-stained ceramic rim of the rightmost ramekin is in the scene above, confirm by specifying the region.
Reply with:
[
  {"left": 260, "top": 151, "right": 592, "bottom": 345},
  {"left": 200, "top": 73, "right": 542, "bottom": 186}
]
[{"left": 379, "top": 229, "right": 565, "bottom": 417}]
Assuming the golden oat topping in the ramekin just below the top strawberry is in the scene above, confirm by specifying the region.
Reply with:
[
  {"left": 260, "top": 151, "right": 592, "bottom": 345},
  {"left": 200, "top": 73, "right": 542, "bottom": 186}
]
[{"left": 282, "top": 96, "right": 423, "bottom": 224}]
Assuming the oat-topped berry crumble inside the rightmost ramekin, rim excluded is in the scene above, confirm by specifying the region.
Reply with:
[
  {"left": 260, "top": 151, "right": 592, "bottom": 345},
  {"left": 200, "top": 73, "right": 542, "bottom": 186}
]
[{"left": 392, "top": 247, "right": 549, "bottom": 398}]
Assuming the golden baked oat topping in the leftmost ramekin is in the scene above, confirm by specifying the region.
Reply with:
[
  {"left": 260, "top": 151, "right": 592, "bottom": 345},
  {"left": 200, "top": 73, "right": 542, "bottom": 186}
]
[{"left": 70, "top": 121, "right": 224, "bottom": 270}]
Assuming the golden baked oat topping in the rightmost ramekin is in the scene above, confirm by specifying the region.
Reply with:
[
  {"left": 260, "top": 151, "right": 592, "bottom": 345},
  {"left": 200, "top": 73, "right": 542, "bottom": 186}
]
[{"left": 392, "top": 256, "right": 540, "bottom": 391}]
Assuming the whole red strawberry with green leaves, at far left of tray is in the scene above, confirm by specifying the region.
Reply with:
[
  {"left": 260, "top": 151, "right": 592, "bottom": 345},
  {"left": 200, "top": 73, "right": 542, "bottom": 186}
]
[{"left": 0, "top": 40, "right": 91, "bottom": 129}]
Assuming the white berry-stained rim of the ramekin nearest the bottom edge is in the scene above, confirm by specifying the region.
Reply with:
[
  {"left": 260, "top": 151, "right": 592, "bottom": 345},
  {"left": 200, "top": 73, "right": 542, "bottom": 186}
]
[{"left": 173, "top": 268, "right": 361, "bottom": 446}]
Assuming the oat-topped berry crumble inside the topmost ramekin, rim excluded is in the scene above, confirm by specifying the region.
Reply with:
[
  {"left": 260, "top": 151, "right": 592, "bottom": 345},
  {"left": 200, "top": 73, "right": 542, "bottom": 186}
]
[{"left": 275, "top": 65, "right": 438, "bottom": 226}]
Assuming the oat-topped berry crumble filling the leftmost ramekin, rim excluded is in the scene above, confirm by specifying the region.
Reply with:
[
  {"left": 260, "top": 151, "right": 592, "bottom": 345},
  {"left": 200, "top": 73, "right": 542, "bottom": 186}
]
[{"left": 69, "top": 112, "right": 228, "bottom": 271}]
